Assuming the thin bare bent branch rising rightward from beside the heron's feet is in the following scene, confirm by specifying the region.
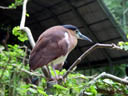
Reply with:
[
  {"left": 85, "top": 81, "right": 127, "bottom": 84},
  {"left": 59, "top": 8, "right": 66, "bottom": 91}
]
[{"left": 63, "top": 43, "right": 122, "bottom": 78}]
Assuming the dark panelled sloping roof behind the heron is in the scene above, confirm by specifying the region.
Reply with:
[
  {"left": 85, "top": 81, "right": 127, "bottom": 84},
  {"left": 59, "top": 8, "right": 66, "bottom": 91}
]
[{"left": 0, "top": 0, "right": 128, "bottom": 68}]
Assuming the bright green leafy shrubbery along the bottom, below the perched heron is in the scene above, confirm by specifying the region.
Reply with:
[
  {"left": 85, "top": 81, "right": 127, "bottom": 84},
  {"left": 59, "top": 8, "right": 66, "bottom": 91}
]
[{"left": 0, "top": 45, "right": 128, "bottom": 96}]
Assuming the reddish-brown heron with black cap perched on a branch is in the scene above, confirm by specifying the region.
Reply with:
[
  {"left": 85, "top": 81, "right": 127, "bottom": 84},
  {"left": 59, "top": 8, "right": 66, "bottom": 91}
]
[{"left": 29, "top": 25, "right": 92, "bottom": 79}]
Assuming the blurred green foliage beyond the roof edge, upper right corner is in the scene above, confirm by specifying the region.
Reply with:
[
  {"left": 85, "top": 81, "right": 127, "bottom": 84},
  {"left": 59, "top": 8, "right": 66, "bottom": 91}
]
[{"left": 103, "top": 0, "right": 128, "bottom": 33}]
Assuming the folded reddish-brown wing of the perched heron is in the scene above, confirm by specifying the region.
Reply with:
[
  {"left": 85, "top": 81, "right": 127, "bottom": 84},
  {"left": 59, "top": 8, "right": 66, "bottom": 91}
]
[{"left": 29, "top": 26, "right": 68, "bottom": 70}]
